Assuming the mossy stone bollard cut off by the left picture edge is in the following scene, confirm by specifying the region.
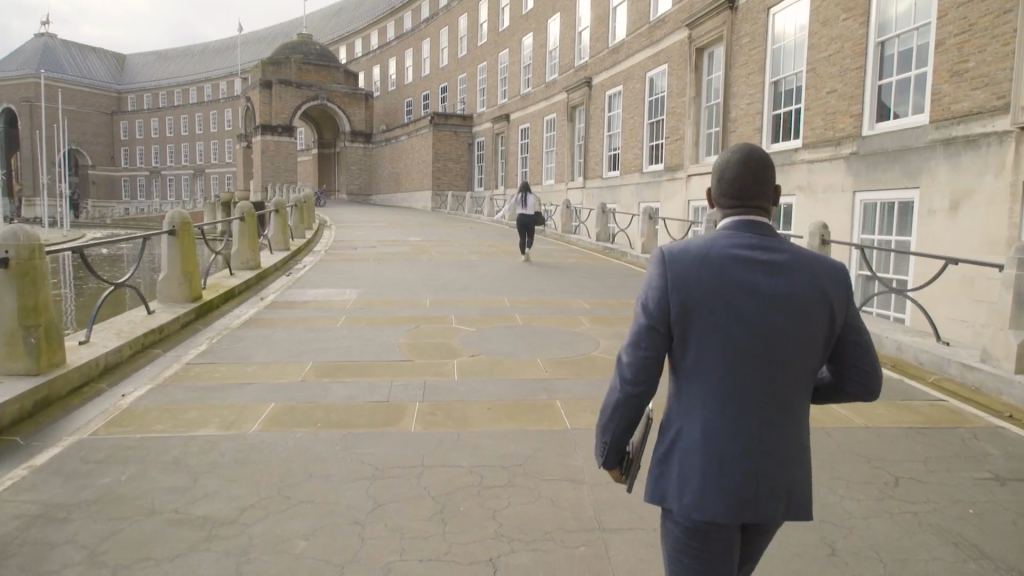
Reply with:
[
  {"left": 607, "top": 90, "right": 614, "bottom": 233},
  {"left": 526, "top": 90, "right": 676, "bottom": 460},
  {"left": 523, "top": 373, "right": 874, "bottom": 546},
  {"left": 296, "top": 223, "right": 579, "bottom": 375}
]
[{"left": 0, "top": 224, "right": 68, "bottom": 376}]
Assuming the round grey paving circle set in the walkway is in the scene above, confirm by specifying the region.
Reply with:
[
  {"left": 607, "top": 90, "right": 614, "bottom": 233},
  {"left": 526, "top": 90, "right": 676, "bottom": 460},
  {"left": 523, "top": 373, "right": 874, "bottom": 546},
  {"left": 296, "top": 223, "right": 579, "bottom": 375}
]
[{"left": 459, "top": 326, "right": 601, "bottom": 359}]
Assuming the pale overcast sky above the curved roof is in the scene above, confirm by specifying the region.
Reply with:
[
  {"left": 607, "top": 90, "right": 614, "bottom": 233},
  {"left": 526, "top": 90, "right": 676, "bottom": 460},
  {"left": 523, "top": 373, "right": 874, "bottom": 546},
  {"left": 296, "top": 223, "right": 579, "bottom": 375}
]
[{"left": 0, "top": 0, "right": 337, "bottom": 57}]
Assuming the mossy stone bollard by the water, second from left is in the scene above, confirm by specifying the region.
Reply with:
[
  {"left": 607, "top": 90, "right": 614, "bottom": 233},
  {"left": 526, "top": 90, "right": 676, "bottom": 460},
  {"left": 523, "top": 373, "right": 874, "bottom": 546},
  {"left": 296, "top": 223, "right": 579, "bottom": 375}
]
[{"left": 157, "top": 210, "right": 203, "bottom": 304}]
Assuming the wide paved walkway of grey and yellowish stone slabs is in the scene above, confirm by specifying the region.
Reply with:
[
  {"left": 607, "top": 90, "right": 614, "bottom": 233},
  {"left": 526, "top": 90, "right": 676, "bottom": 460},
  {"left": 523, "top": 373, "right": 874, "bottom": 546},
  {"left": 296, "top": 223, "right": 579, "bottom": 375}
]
[{"left": 0, "top": 205, "right": 1024, "bottom": 576}]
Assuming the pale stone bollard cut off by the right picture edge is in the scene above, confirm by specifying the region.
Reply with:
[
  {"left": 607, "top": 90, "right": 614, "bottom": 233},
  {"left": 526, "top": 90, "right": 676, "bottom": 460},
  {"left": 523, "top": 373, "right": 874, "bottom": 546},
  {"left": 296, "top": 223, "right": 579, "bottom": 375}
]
[{"left": 981, "top": 242, "right": 1024, "bottom": 375}]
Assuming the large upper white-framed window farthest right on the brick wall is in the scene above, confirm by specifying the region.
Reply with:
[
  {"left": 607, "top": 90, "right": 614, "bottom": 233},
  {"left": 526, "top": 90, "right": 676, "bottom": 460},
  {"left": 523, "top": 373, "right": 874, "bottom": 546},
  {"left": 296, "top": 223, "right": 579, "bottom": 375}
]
[{"left": 864, "top": 0, "right": 938, "bottom": 133}]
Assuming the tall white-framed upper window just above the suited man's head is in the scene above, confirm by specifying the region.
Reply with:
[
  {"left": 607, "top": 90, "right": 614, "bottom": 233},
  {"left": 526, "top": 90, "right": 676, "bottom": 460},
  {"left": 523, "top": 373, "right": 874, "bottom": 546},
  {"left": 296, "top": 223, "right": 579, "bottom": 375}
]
[{"left": 764, "top": 0, "right": 810, "bottom": 150}]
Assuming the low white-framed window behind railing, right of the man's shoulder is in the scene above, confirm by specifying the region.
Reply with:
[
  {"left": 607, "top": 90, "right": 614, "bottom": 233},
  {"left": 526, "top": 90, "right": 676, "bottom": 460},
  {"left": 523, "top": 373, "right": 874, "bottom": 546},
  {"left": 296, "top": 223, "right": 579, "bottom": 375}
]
[{"left": 850, "top": 190, "right": 920, "bottom": 324}]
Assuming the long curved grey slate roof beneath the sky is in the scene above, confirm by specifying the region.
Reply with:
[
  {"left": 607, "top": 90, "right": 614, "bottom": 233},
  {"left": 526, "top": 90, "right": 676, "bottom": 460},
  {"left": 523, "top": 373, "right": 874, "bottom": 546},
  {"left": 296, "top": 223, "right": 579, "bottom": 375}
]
[{"left": 0, "top": 0, "right": 414, "bottom": 90}]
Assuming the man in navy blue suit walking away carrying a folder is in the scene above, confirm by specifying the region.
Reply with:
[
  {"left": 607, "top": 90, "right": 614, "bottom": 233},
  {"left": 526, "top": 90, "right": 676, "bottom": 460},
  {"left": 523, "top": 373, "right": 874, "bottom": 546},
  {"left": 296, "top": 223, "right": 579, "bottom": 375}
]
[{"left": 595, "top": 145, "right": 882, "bottom": 576}]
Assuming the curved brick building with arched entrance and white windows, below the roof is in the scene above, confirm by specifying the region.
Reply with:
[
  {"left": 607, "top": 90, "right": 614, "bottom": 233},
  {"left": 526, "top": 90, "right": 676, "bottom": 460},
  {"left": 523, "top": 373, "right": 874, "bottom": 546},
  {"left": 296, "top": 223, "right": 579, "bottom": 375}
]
[{"left": 0, "top": 0, "right": 1024, "bottom": 350}]
